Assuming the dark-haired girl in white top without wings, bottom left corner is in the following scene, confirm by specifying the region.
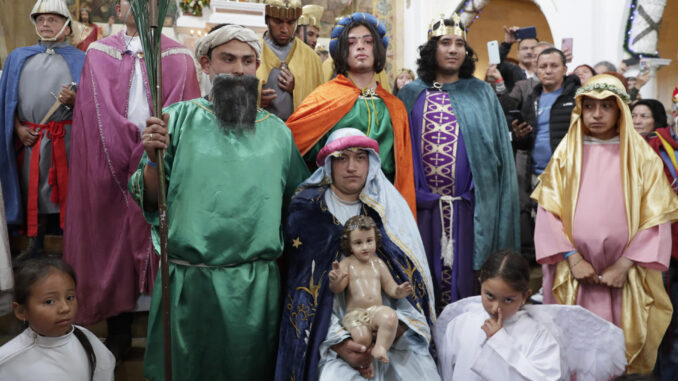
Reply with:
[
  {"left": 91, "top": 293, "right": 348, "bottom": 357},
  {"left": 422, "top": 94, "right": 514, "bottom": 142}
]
[{"left": 0, "top": 258, "right": 115, "bottom": 381}]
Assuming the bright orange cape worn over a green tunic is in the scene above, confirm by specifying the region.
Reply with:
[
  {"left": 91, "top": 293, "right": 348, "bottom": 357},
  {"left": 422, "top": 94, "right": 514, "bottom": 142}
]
[{"left": 287, "top": 74, "right": 417, "bottom": 218}]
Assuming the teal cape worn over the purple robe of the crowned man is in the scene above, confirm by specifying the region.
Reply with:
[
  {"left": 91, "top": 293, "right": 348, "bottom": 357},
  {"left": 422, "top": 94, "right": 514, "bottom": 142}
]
[{"left": 398, "top": 77, "right": 520, "bottom": 270}]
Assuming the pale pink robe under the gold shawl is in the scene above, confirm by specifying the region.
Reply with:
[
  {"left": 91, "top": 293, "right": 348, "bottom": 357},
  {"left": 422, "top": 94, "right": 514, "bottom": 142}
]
[{"left": 534, "top": 143, "right": 671, "bottom": 326}]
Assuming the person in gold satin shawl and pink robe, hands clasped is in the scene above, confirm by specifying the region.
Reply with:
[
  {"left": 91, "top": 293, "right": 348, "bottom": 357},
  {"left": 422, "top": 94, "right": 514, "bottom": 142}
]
[{"left": 532, "top": 74, "right": 678, "bottom": 373}]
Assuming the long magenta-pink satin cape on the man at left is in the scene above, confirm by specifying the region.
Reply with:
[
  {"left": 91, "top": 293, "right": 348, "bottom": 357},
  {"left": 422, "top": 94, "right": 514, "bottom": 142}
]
[{"left": 63, "top": 32, "right": 200, "bottom": 325}]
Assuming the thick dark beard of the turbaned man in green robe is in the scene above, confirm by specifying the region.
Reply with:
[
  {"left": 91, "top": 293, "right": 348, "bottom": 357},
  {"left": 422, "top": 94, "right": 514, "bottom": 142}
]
[{"left": 211, "top": 74, "right": 259, "bottom": 132}]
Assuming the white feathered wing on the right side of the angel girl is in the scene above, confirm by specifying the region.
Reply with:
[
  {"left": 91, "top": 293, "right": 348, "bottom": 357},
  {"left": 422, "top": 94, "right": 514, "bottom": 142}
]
[{"left": 525, "top": 304, "right": 626, "bottom": 381}]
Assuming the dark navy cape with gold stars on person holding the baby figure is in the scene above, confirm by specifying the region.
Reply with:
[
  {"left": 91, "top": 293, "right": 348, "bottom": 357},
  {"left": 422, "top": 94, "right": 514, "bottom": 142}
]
[{"left": 275, "top": 186, "right": 433, "bottom": 381}]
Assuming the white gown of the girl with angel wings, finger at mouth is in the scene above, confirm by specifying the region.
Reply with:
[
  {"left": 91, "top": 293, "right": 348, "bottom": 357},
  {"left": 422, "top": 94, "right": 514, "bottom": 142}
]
[{"left": 435, "top": 298, "right": 561, "bottom": 381}]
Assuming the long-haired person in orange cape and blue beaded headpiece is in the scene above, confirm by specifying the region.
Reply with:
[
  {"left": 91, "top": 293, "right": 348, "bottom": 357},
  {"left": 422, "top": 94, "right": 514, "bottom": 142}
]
[{"left": 287, "top": 12, "right": 415, "bottom": 217}]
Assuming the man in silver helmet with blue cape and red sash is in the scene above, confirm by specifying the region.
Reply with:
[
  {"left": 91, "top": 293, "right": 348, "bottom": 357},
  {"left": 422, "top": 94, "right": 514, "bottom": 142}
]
[{"left": 0, "top": 0, "right": 85, "bottom": 258}]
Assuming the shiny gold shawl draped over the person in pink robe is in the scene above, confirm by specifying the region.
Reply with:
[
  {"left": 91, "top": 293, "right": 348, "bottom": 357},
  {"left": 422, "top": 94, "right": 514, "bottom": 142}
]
[{"left": 531, "top": 74, "right": 678, "bottom": 373}]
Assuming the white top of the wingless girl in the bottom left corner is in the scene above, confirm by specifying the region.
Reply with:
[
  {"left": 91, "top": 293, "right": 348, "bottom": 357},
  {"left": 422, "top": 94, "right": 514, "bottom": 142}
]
[{"left": 0, "top": 327, "right": 115, "bottom": 381}]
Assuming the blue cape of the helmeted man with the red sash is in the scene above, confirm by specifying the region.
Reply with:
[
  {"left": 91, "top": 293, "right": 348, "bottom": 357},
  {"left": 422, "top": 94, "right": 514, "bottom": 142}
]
[{"left": 0, "top": 44, "right": 85, "bottom": 225}]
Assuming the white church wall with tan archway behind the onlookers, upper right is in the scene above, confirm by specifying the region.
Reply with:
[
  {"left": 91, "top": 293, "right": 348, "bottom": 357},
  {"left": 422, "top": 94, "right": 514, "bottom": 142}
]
[{"left": 403, "top": 0, "right": 678, "bottom": 106}]
